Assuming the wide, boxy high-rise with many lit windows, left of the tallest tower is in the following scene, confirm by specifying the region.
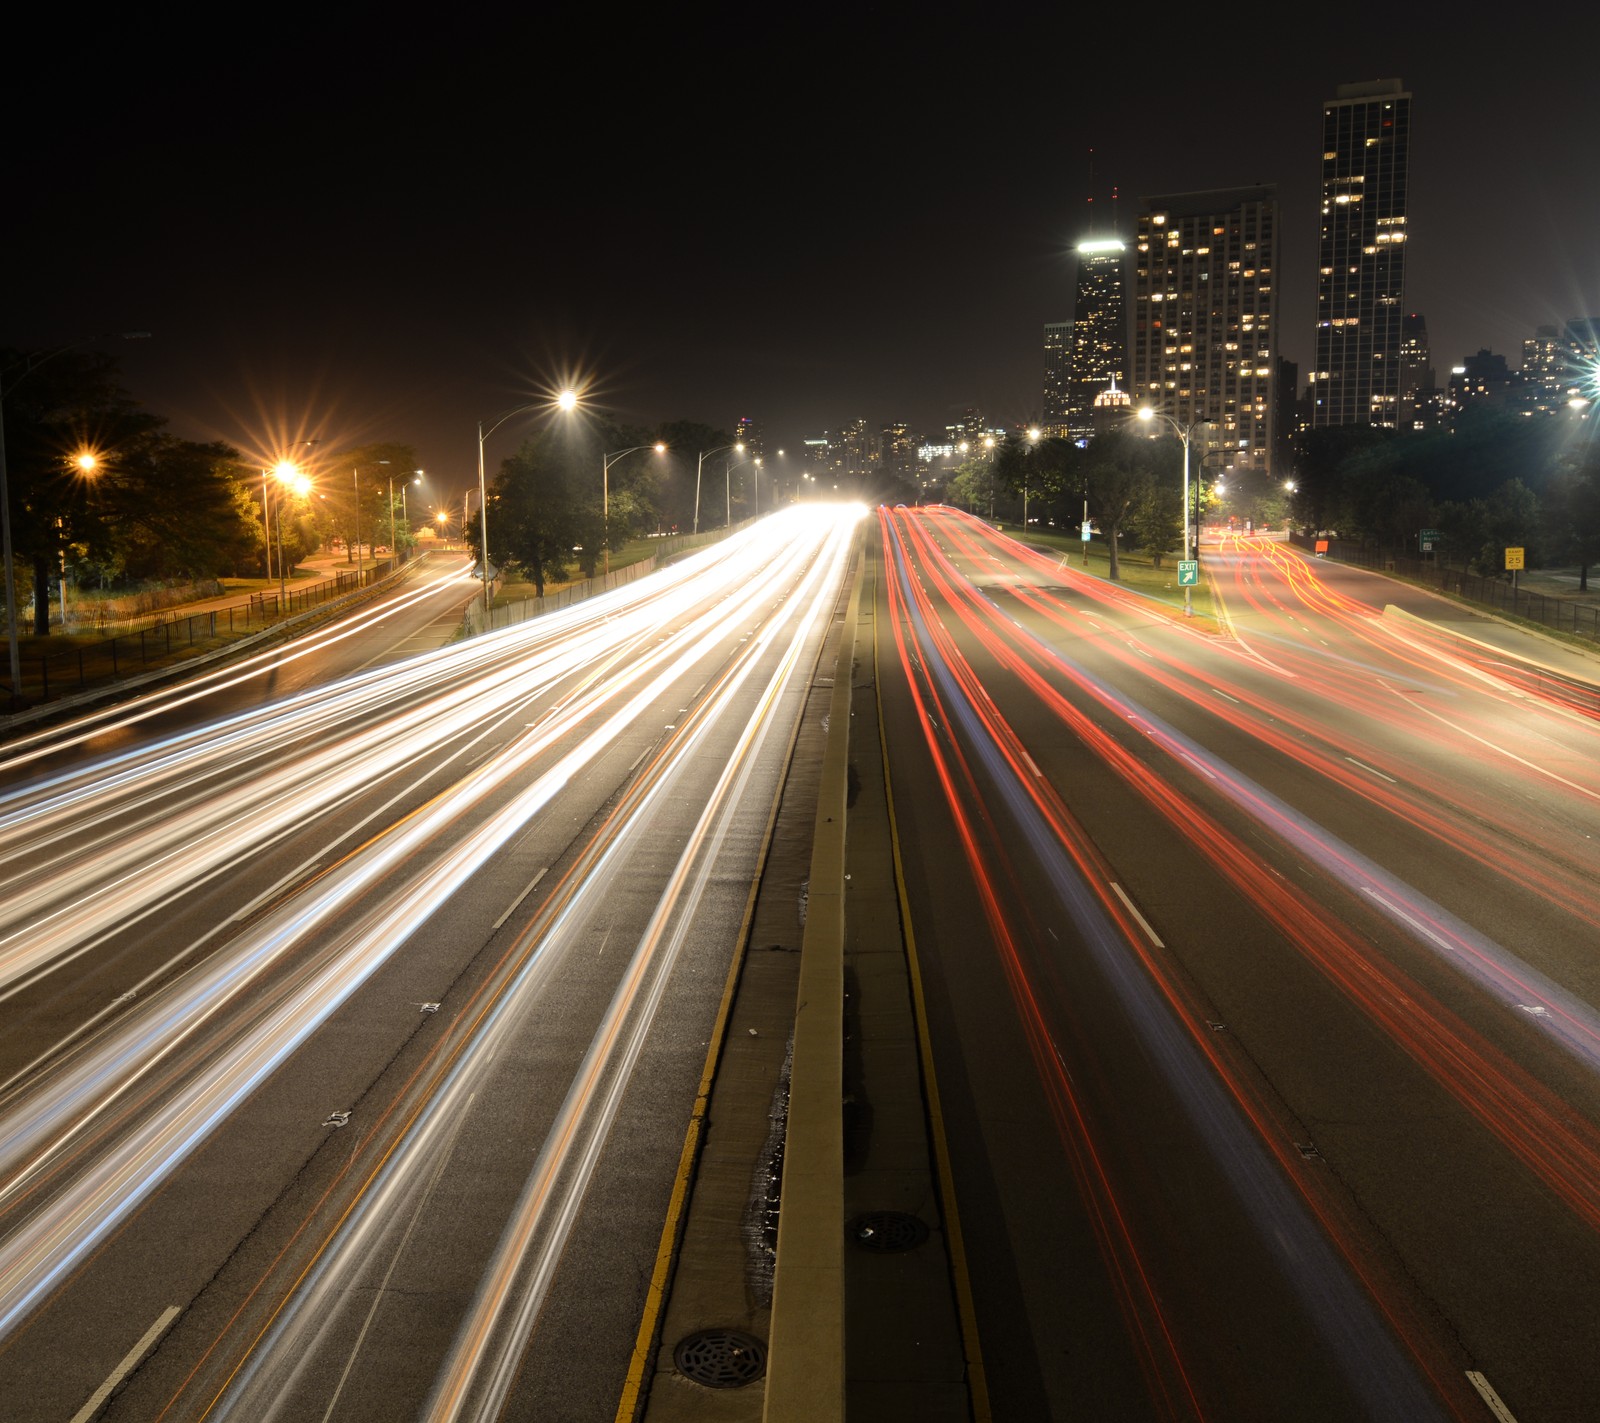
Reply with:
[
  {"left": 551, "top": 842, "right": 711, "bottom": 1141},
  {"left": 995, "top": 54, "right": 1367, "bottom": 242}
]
[{"left": 1131, "top": 186, "right": 1278, "bottom": 474}]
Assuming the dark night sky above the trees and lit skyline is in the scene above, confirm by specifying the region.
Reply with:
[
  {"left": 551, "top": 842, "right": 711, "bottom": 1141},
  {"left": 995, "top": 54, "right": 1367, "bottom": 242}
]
[{"left": 12, "top": 5, "right": 1600, "bottom": 499}]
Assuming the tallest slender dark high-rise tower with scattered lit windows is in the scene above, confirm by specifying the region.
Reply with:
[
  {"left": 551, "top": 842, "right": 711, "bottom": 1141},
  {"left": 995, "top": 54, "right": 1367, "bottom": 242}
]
[{"left": 1310, "top": 78, "right": 1411, "bottom": 427}]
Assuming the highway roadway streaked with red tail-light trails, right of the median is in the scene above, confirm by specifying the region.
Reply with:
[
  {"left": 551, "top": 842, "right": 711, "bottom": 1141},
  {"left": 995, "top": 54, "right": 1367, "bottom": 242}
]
[{"left": 874, "top": 507, "right": 1600, "bottom": 1423}]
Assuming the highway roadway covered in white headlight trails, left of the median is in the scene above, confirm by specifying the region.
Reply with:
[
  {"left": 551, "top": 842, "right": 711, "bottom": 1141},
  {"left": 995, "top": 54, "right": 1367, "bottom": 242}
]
[{"left": 0, "top": 507, "right": 859, "bottom": 1423}]
